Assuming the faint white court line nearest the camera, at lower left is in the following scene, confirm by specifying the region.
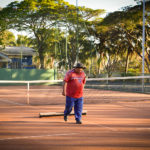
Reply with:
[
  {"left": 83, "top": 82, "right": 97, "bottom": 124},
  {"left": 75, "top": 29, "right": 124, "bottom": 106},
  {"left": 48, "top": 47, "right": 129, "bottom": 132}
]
[{"left": 0, "top": 133, "right": 77, "bottom": 141}]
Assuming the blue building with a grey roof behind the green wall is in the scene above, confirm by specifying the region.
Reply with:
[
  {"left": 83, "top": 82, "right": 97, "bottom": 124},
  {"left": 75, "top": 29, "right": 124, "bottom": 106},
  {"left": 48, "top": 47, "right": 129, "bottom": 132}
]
[{"left": 0, "top": 46, "right": 36, "bottom": 69}]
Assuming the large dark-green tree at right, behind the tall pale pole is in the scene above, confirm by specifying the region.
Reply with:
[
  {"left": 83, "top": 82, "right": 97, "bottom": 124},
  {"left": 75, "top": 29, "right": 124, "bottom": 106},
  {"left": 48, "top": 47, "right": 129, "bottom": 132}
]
[{"left": 92, "top": 1, "right": 150, "bottom": 73}]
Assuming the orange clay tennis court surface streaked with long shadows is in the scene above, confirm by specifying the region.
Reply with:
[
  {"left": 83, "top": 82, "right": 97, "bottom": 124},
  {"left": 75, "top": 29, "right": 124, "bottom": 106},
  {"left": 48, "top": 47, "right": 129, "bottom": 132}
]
[{"left": 0, "top": 86, "right": 150, "bottom": 150}]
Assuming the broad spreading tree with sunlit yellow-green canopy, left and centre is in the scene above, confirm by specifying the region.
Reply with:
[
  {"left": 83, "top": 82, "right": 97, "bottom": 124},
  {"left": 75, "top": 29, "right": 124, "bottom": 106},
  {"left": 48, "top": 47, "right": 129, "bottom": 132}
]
[{"left": 2, "top": 0, "right": 104, "bottom": 68}]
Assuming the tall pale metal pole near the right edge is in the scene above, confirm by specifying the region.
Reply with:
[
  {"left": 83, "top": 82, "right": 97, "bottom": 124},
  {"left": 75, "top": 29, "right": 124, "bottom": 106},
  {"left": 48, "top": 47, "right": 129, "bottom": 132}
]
[{"left": 142, "top": 0, "right": 145, "bottom": 92}]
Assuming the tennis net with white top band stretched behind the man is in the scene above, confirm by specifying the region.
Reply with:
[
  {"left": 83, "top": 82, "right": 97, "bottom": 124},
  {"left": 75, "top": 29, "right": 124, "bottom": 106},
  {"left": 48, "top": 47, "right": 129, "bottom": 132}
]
[{"left": 0, "top": 76, "right": 150, "bottom": 105}]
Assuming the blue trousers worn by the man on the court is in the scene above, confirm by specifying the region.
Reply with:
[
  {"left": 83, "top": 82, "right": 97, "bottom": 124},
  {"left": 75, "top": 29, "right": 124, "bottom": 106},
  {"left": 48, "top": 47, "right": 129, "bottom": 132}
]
[{"left": 64, "top": 96, "right": 83, "bottom": 121}]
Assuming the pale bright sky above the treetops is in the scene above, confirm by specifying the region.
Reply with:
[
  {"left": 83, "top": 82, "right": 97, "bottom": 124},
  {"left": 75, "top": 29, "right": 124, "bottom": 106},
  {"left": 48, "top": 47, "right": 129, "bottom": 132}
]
[{"left": 0, "top": 0, "right": 136, "bottom": 12}]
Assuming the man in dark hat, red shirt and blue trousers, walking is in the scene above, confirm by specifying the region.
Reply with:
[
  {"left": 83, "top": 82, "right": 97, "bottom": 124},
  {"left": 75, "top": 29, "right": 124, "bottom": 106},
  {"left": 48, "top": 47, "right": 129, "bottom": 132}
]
[{"left": 62, "top": 63, "right": 86, "bottom": 124}]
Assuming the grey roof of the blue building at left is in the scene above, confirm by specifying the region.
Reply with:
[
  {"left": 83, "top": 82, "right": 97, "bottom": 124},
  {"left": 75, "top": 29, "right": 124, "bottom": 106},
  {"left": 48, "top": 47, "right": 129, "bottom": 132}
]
[{"left": 2, "top": 46, "right": 36, "bottom": 56}]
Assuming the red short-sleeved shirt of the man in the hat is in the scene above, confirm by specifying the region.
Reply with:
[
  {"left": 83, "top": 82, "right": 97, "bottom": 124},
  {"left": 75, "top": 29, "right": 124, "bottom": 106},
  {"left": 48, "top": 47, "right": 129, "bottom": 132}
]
[{"left": 64, "top": 69, "right": 86, "bottom": 98}]
